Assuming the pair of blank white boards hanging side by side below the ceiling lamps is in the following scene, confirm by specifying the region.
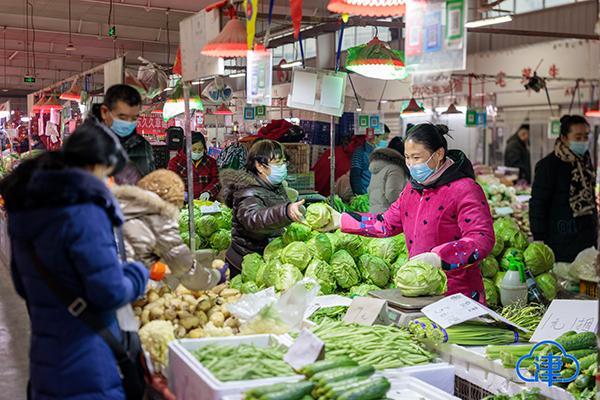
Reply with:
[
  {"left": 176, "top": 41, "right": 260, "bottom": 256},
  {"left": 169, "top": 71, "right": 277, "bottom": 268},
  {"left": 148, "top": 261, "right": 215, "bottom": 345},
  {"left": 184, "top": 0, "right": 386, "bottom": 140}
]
[{"left": 287, "top": 68, "right": 348, "bottom": 117}]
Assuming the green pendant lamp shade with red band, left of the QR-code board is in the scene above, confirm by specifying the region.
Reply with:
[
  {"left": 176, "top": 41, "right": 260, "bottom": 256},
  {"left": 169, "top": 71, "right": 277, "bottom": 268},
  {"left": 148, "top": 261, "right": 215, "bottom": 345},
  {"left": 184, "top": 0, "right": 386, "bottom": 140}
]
[{"left": 346, "top": 36, "right": 408, "bottom": 80}]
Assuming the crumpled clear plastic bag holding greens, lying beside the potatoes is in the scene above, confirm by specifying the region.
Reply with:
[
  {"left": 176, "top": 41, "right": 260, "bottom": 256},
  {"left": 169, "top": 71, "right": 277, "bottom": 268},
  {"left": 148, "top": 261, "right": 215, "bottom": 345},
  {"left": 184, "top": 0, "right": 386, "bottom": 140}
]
[{"left": 227, "top": 278, "right": 320, "bottom": 335}]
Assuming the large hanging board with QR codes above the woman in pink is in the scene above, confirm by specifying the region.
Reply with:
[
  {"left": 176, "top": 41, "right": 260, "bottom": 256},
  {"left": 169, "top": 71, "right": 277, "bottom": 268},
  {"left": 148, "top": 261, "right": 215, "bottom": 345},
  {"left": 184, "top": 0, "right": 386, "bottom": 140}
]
[{"left": 404, "top": 0, "right": 467, "bottom": 74}]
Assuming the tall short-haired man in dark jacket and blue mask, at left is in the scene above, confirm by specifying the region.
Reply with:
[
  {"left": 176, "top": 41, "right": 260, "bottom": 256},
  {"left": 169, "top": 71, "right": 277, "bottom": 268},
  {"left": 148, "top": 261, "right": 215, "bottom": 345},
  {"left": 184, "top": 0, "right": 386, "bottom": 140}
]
[{"left": 100, "top": 85, "right": 156, "bottom": 184}]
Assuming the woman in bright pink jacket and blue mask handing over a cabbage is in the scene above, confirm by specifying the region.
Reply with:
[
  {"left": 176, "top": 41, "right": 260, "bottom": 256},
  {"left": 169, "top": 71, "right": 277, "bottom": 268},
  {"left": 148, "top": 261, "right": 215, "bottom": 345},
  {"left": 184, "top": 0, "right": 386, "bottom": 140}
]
[{"left": 332, "top": 124, "right": 495, "bottom": 303}]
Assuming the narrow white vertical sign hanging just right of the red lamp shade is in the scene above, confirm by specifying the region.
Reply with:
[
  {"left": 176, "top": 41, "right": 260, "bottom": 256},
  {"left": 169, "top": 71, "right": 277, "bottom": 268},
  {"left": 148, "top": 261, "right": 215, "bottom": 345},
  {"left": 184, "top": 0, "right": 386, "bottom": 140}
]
[{"left": 246, "top": 50, "right": 273, "bottom": 106}]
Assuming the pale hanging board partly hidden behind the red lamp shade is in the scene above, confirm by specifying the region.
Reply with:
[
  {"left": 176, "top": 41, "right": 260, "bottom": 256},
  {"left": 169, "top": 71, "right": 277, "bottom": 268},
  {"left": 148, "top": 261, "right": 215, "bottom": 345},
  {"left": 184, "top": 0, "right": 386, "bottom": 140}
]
[{"left": 179, "top": 9, "right": 225, "bottom": 81}]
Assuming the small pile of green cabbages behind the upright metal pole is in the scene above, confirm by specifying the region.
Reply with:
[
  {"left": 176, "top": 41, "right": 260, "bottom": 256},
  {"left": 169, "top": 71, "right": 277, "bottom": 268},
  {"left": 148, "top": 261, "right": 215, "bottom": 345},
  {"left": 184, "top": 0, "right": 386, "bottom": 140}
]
[{"left": 179, "top": 204, "right": 231, "bottom": 251}]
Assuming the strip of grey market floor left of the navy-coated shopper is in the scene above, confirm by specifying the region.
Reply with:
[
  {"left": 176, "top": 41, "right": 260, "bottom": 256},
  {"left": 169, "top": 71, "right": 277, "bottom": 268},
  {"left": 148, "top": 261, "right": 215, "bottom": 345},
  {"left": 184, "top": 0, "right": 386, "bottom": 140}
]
[{"left": 0, "top": 261, "right": 29, "bottom": 400}]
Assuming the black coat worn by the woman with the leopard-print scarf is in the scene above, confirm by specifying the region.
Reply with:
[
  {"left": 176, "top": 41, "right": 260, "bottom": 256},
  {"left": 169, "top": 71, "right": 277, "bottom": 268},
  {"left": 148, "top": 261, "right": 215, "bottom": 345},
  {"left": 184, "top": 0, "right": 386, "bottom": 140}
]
[{"left": 529, "top": 152, "right": 598, "bottom": 262}]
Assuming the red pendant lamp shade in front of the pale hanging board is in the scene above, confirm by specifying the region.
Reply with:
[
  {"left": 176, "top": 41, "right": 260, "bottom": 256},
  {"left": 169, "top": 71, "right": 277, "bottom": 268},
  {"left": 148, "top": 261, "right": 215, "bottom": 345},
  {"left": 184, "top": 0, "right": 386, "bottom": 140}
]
[{"left": 201, "top": 18, "right": 248, "bottom": 58}]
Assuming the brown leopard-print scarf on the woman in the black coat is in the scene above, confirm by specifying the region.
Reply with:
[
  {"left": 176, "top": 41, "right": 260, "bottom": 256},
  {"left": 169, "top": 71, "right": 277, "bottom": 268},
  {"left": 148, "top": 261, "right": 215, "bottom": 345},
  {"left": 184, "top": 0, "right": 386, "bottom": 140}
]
[{"left": 554, "top": 138, "right": 596, "bottom": 217}]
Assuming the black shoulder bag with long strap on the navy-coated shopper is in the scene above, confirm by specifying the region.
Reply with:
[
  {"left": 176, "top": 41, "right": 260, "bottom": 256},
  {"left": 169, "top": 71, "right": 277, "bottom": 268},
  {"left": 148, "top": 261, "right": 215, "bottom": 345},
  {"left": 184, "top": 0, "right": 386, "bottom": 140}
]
[{"left": 29, "top": 243, "right": 147, "bottom": 400}]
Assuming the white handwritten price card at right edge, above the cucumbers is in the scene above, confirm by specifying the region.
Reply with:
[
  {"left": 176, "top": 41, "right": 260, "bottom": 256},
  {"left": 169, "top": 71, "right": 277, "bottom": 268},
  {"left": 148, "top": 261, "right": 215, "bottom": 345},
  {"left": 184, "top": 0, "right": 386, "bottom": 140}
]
[{"left": 529, "top": 300, "right": 598, "bottom": 342}]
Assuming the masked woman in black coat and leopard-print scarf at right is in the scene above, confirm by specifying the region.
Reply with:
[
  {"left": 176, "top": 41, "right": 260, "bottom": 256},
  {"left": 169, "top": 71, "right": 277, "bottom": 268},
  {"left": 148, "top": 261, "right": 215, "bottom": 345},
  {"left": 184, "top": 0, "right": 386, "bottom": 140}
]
[{"left": 529, "top": 115, "right": 598, "bottom": 262}]
